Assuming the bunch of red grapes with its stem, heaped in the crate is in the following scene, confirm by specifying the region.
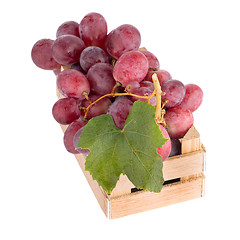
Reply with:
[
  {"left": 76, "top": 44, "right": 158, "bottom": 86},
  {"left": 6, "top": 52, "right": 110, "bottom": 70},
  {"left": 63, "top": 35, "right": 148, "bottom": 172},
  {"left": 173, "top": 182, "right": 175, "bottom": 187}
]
[{"left": 31, "top": 12, "right": 203, "bottom": 160}]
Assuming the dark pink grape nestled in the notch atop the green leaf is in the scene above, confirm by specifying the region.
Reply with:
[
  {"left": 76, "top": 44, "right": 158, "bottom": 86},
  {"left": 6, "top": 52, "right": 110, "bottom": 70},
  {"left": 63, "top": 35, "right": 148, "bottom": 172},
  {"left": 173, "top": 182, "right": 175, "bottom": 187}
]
[{"left": 107, "top": 96, "right": 133, "bottom": 129}]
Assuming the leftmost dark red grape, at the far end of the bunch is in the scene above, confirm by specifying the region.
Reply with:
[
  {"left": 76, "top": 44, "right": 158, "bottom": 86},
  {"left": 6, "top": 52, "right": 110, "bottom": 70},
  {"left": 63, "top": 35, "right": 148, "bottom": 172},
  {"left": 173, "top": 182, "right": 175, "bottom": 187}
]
[{"left": 31, "top": 39, "right": 61, "bottom": 70}]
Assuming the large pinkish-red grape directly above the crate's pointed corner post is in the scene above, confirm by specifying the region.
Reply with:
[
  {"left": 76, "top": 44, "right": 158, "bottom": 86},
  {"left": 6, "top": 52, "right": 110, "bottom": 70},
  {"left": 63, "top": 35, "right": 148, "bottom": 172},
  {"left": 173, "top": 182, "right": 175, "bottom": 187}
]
[{"left": 164, "top": 106, "right": 193, "bottom": 138}]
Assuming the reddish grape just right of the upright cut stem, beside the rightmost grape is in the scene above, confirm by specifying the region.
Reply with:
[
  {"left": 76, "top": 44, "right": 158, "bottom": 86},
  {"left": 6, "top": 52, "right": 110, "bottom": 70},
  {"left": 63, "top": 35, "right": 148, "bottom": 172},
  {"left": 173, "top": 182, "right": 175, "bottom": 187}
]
[{"left": 162, "top": 80, "right": 186, "bottom": 108}]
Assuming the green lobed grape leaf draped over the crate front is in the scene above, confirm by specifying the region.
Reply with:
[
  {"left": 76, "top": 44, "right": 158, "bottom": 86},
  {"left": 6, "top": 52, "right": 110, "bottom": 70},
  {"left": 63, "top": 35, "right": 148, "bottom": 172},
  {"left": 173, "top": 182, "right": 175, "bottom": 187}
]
[{"left": 77, "top": 101, "right": 167, "bottom": 194}]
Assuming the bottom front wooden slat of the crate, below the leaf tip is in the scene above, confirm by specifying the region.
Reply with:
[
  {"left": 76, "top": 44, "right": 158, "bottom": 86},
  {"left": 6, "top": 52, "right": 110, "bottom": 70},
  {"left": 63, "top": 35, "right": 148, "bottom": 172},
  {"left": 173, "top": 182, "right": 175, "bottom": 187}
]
[{"left": 109, "top": 173, "right": 204, "bottom": 219}]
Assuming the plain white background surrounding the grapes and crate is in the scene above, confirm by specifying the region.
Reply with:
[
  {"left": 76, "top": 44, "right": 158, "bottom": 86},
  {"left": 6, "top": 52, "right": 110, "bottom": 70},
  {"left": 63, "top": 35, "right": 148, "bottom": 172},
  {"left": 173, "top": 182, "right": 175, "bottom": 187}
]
[{"left": 0, "top": 0, "right": 240, "bottom": 240}]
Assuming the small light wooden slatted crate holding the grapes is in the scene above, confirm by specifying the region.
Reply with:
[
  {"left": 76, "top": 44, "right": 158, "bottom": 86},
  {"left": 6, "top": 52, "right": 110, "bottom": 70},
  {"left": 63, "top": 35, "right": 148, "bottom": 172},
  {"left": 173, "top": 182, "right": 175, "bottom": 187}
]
[{"left": 58, "top": 93, "right": 206, "bottom": 219}]
